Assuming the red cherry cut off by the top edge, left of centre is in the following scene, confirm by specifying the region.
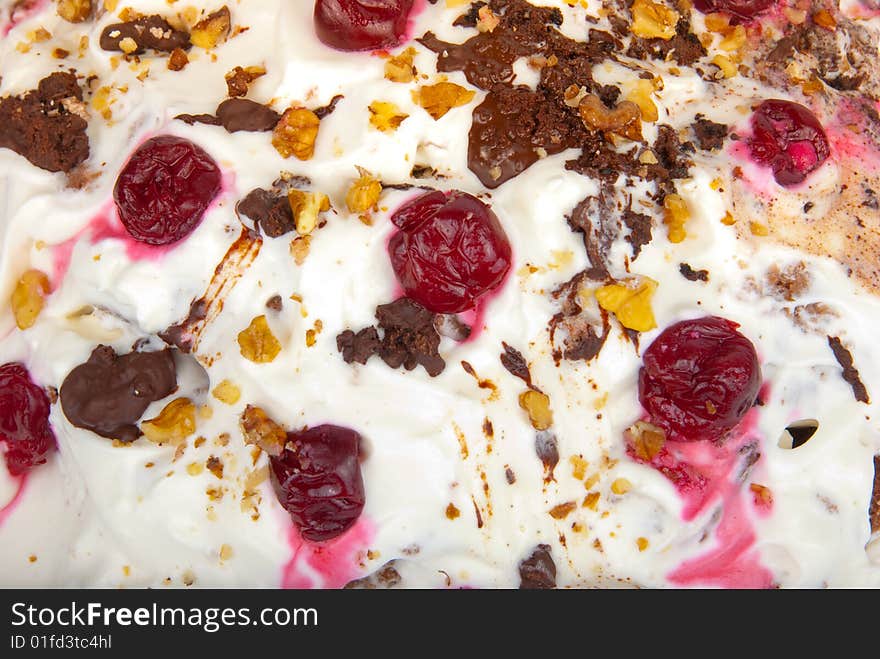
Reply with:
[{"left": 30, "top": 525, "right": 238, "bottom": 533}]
[{"left": 315, "top": 0, "right": 414, "bottom": 51}]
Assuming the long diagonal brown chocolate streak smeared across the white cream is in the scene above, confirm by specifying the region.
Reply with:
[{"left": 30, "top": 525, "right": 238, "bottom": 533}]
[{"left": 159, "top": 227, "right": 263, "bottom": 353}]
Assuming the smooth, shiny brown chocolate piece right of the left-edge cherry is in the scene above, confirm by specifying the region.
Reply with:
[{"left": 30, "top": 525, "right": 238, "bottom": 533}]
[{"left": 61, "top": 346, "right": 177, "bottom": 442}]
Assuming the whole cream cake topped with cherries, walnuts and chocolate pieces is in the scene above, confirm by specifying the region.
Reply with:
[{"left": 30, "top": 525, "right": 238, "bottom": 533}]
[{"left": 0, "top": 0, "right": 880, "bottom": 588}]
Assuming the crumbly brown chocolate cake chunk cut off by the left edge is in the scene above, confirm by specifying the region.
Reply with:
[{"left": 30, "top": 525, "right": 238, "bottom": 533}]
[{"left": 0, "top": 73, "right": 89, "bottom": 172}]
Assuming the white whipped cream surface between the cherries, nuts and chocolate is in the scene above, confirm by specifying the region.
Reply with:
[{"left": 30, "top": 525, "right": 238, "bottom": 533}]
[{"left": 0, "top": 0, "right": 880, "bottom": 588}]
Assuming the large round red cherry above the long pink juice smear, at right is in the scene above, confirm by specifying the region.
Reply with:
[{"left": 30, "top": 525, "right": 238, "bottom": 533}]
[{"left": 639, "top": 316, "right": 761, "bottom": 442}]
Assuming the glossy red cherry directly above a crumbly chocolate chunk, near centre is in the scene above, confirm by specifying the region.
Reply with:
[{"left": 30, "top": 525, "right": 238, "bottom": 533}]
[{"left": 388, "top": 191, "right": 511, "bottom": 314}]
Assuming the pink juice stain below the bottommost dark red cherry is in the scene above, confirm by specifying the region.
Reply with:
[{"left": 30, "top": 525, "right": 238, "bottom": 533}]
[{"left": 281, "top": 517, "right": 375, "bottom": 589}]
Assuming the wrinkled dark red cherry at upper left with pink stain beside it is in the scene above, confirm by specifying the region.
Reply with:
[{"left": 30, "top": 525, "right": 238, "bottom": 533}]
[{"left": 113, "top": 135, "right": 221, "bottom": 245}]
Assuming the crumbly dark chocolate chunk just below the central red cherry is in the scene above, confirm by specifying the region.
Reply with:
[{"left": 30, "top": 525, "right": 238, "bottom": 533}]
[{"left": 336, "top": 297, "right": 446, "bottom": 377}]
